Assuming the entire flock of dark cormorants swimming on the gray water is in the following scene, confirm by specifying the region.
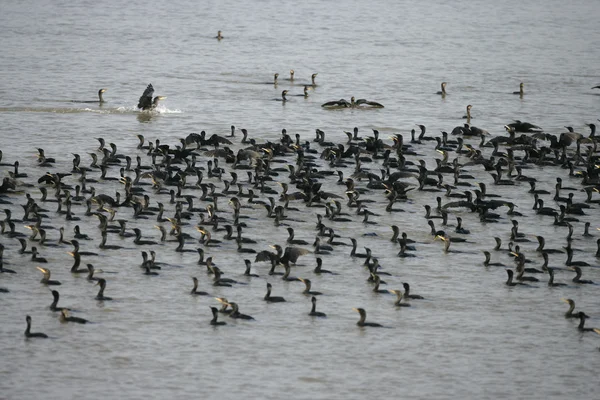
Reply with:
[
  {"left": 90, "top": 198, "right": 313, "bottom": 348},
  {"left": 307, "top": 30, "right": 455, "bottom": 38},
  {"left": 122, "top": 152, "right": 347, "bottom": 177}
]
[{"left": 0, "top": 76, "right": 600, "bottom": 346}]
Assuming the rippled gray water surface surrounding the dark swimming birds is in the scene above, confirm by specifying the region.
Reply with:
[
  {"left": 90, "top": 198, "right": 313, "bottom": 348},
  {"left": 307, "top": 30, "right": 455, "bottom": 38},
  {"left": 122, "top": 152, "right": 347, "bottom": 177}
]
[{"left": 0, "top": 0, "right": 600, "bottom": 399}]
